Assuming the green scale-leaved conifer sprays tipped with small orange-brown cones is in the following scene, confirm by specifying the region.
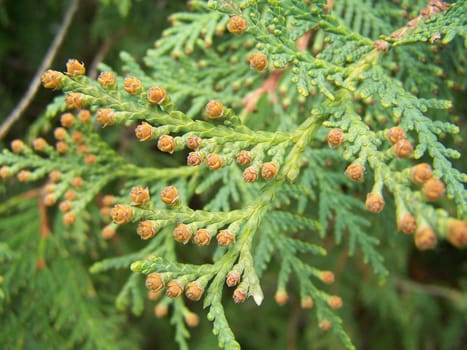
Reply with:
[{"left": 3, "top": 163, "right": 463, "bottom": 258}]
[{"left": 0, "top": 0, "right": 467, "bottom": 349}]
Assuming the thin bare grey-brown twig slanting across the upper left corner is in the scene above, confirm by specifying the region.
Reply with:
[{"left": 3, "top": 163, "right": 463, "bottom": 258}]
[{"left": 0, "top": 0, "right": 79, "bottom": 139}]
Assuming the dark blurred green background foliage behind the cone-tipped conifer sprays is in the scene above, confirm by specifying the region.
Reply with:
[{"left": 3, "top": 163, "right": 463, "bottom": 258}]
[{"left": 0, "top": 0, "right": 467, "bottom": 350}]
